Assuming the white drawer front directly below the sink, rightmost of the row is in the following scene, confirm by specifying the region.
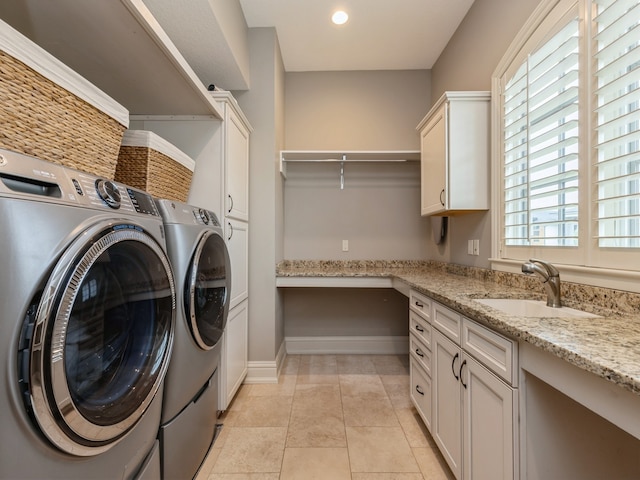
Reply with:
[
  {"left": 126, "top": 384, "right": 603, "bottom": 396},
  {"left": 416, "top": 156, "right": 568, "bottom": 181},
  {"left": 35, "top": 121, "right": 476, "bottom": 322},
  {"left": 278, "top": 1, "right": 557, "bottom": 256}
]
[{"left": 461, "top": 318, "right": 518, "bottom": 386}]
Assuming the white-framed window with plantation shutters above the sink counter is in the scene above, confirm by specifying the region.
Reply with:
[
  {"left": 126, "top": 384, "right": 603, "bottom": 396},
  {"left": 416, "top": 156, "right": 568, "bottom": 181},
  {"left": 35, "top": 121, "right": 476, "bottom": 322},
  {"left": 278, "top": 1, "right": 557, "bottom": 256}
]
[{"left": 493, "top": 0, "right": 640, "bottom": 284}]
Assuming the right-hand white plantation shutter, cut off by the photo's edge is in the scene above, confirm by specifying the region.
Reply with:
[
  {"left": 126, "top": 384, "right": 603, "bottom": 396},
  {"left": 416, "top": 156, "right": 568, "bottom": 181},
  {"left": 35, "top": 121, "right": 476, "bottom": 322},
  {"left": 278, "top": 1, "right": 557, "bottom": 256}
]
[{"left": 595, "top": 0, "right": 640, "bottom": 248}]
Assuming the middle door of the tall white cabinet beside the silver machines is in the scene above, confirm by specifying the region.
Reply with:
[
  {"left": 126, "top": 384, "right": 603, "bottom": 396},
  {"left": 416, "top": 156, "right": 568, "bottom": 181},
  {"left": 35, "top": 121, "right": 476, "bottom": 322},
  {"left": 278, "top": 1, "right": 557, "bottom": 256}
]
[{"left": 225, "top": 219, "right": 249, "bottom": 308}]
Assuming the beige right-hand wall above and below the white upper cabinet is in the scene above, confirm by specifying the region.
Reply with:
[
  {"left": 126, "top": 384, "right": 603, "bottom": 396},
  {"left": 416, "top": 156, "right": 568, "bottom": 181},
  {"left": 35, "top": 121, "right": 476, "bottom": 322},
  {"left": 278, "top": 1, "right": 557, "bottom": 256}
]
[{"left": 429, "top": 0, "right": 540, "bottom": 268}]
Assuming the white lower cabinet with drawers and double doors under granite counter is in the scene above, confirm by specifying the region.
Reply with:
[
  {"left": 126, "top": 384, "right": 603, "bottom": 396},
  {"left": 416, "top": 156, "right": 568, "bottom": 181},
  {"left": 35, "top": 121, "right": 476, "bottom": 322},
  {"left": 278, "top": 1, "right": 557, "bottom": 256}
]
[{"left": 409, "top": 292, "right": 518, "bottom": 480}]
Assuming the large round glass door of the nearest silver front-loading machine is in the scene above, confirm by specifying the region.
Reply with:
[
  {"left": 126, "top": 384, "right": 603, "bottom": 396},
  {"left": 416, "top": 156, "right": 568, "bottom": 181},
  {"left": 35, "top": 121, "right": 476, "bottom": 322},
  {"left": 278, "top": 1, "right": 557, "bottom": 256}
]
[{"left": 19, "top": 222, "right": 175, "bottom": 456}]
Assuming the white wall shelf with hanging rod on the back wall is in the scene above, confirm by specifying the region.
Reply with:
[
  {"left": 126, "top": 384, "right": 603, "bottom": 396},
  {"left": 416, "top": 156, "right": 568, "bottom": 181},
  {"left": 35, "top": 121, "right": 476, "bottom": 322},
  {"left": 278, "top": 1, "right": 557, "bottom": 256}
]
[{"left": 280, "top": 150, "right": 420, "bottom": 189}]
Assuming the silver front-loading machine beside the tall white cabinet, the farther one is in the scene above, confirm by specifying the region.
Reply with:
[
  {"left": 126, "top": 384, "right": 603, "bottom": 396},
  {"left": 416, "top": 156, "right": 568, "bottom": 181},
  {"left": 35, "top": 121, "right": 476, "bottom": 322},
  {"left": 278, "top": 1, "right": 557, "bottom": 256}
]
[{"left": 156, "top": 200, "right": 231, "bottom": 480}]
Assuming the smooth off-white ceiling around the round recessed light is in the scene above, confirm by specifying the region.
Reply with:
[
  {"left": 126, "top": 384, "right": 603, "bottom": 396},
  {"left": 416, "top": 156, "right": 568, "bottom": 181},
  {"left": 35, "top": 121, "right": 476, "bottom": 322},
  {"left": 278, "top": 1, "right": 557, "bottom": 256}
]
[{"left": 240, "top": 0, "right": 473, "bottom": 72}]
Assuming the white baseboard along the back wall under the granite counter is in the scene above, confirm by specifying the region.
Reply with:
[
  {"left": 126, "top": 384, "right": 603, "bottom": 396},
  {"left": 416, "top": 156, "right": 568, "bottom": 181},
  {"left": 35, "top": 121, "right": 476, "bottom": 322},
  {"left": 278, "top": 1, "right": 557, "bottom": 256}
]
[{"left": 284, "top": 336, "right": 409, "bottom": 355}]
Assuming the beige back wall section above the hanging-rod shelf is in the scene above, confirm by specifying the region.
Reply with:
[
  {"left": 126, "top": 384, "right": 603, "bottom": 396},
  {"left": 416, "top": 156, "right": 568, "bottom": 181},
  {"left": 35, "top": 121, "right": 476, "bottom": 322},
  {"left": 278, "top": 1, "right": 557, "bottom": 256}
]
[{"left": 285, "top": 70, "right": 431, "bottom": 150}]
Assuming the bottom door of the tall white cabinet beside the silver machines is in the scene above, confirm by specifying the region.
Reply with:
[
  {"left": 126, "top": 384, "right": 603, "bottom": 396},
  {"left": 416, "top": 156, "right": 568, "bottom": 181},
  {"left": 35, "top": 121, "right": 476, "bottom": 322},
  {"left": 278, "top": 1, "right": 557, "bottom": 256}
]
[{"left": 218, "top": 300, "right": 249, "bottom": 410}]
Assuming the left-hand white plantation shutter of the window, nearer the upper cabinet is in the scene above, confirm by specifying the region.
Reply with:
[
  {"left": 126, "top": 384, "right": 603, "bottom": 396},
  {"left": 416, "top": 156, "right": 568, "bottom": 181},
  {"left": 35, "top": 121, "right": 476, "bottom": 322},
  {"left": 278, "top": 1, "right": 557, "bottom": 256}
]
[{"left": 503, "top": 17, "right": 579, "bottom": 246}]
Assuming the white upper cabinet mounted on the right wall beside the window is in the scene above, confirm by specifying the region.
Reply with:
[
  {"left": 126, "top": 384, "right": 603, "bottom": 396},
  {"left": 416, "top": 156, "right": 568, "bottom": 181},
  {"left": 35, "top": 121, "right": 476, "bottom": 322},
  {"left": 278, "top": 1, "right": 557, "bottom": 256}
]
[{"left": 417, "top": 92, "right": 491, "bottom": 216}]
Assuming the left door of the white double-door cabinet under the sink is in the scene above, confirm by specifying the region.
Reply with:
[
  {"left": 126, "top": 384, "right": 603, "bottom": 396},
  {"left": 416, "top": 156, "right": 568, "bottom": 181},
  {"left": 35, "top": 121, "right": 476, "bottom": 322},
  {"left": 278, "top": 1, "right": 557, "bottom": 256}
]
[{"left": 431, "top": 329, "right": 462, "bottom": 479}]
